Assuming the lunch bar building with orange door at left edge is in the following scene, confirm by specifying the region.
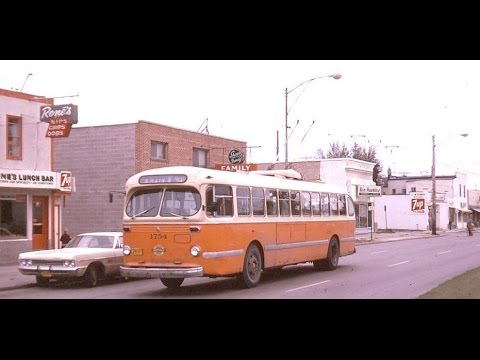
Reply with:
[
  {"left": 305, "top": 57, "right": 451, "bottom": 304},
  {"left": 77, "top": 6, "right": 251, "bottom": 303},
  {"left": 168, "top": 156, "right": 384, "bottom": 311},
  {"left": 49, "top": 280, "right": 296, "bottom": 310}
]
[{"left": 0, "top": 89, "right": 70, "bottom": 264}]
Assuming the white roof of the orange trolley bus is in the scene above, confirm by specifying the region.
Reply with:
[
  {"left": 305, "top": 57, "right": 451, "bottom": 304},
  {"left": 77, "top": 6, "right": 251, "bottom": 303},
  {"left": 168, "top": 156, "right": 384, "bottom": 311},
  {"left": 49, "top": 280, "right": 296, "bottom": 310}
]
[{"left": 126, "top": 166, "right": 346, "bottom": 194}]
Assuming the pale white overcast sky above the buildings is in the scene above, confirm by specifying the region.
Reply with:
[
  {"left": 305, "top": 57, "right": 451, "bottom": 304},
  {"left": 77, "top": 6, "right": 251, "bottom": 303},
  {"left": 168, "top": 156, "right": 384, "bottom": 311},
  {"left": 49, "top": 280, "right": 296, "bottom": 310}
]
[{"left": 0, "top": 60, "right": 480, "bottom": 189}]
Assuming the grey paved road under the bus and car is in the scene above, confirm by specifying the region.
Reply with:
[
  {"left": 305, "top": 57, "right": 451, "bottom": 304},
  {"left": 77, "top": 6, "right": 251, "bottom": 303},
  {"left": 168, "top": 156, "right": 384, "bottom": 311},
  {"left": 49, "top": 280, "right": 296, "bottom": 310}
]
[{"left": 0, "top": 232, "right": 480, "bottom": 299}]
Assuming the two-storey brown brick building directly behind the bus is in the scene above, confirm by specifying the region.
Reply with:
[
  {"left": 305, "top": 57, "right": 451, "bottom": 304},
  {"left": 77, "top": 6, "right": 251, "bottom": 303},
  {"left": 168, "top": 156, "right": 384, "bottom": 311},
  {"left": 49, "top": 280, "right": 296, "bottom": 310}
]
[{"left": 54, "top": 121, "right": 246, "bottom": 235}]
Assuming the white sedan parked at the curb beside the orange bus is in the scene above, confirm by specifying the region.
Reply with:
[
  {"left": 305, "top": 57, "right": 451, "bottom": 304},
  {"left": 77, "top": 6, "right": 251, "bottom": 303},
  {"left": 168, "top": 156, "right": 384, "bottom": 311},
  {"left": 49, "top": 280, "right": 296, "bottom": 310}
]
[{"left": 18, "top": 232, "right": 123, "bottom": 287}]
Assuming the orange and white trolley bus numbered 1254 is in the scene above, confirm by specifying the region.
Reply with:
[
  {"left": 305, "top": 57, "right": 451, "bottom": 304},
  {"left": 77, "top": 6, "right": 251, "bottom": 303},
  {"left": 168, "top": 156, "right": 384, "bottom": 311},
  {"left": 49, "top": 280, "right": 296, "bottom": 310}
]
[{"left": 120, "top": 166, "right": 355, "bottom": 288}]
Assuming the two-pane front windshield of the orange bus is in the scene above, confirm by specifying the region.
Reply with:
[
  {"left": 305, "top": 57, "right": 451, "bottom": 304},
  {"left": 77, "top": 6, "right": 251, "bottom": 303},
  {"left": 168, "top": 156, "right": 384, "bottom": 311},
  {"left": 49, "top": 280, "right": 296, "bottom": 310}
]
[{"left": 125, "top": 187, "right": 201, "bottom": 218}]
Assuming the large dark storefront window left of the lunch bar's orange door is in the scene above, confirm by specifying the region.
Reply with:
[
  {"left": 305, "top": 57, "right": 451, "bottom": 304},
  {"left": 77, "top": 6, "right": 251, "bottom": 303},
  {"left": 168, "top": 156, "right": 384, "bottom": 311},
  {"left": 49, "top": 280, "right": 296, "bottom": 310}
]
[{"left": 0, "top": 195, "right": 27, "bottom": 240}]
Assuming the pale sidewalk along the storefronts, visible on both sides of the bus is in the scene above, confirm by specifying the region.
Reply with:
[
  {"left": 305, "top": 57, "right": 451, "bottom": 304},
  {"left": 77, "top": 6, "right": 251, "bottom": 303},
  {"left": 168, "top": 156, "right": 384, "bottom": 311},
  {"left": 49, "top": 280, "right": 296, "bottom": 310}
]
[{"left": 0, "top": 229, "right": 466, "bottom": 291}]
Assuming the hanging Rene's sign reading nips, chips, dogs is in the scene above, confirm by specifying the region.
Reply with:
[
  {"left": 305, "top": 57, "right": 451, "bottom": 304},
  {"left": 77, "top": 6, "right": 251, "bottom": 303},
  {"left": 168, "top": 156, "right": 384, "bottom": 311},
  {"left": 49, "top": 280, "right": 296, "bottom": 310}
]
[{"left": 40, "top": 104, "right": 78, "bottom": 138}]
